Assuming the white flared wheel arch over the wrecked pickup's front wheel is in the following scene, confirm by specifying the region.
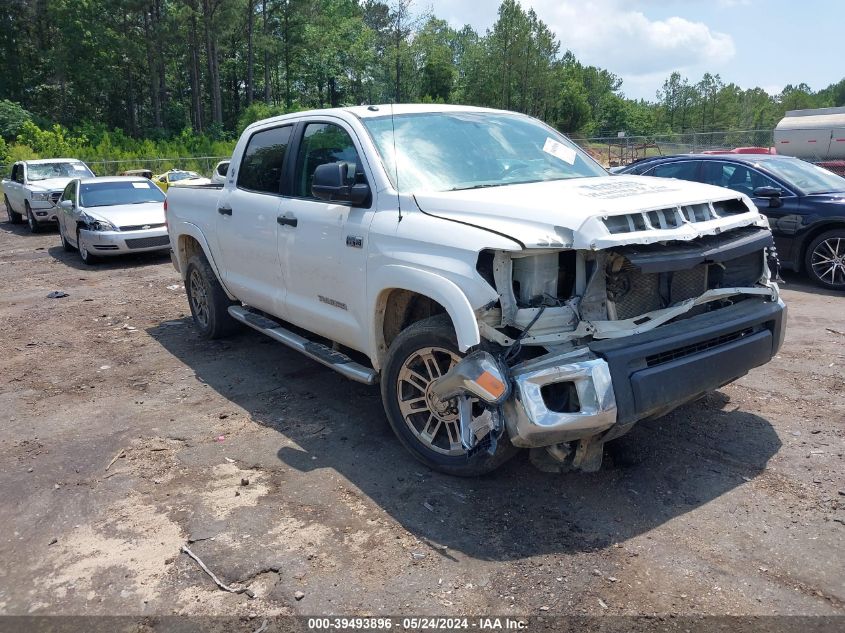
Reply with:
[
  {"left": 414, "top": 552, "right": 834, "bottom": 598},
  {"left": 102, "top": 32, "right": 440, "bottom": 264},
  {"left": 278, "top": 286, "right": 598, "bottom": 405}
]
[{"left": 367, "top": 264, "right": 481, "bottom": 366}]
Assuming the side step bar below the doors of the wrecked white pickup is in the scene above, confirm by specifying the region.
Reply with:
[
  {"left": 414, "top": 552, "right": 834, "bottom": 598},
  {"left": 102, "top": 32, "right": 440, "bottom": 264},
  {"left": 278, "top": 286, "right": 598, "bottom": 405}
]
[{"left": 229, "top": 306, "right": 378, "bottom": 385}]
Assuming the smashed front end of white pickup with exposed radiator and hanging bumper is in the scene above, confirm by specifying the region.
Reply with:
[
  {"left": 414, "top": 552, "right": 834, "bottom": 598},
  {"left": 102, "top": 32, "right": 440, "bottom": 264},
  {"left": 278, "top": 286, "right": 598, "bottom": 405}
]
[{"left": 432, "top": 190, "right": 785, "bottom": 471}]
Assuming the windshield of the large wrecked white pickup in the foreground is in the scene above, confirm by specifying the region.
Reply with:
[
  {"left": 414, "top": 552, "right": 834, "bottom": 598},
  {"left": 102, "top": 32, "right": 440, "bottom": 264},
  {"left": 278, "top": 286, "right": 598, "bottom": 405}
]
[{"left": 363, "top": 112, "right": 607, "bottom": 193}]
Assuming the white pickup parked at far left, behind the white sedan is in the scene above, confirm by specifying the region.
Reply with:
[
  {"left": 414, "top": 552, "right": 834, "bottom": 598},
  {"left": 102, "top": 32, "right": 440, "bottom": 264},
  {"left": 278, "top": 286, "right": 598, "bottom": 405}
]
[{"left": 2, "top": 158, "right": 94, "bottom": 233}]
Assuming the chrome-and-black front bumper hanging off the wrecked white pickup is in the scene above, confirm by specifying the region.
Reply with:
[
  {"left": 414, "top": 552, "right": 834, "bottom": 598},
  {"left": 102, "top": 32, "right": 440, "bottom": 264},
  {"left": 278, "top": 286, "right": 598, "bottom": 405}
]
[{"left": 504, "top": 298, "right": 786, "bottom": 448}]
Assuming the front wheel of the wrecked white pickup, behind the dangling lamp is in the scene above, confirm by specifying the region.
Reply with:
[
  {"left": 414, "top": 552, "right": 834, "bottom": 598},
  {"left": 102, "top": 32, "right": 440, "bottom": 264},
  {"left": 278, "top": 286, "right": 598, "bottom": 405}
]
[{"left": 381, "top": 315, "right": 517, "bottom": 477}]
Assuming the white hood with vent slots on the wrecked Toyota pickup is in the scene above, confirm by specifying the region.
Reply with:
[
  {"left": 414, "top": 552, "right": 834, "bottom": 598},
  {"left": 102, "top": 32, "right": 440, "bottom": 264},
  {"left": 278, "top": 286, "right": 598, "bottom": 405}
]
[{"left": 414, "top": 176, "right": 768, "bottom": 249}]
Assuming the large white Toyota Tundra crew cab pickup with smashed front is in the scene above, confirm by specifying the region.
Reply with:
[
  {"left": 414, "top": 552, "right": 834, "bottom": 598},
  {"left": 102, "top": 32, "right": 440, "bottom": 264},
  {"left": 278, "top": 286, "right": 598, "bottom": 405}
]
[{"left": 166, "top": 105, "right": 785, "bottom": 475}]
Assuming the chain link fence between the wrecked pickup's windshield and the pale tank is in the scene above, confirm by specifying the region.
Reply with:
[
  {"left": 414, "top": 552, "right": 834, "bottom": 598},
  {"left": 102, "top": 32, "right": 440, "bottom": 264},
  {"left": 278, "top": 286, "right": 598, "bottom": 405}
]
[{"left": 572, "top": 130, "right": 773, "bottom": 167}]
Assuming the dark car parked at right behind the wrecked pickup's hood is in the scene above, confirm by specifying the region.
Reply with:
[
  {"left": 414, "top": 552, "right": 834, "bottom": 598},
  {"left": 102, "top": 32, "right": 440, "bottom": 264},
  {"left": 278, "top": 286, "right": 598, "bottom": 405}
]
[{"left": 617, "top": 154, "right": 845, "bottom": 290}]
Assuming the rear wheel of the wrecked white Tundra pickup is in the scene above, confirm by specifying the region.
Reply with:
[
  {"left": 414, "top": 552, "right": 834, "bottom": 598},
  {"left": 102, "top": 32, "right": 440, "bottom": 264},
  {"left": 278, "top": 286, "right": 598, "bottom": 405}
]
[{"left": 185, "top": 255, "right": 237, "bottom": 339}]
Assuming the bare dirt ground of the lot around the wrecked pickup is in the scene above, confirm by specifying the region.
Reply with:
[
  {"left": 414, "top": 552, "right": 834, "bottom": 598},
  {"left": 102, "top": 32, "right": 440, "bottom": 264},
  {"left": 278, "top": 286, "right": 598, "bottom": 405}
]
[{"left": 0, "top": 213, "right": 845, "bottom": 616}]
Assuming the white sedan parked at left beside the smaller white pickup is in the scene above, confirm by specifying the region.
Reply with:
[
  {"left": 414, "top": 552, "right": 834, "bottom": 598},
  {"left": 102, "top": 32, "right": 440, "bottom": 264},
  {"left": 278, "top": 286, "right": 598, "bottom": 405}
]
[{"left": 58, "top": 176, "right": 170, "bottom": 264}]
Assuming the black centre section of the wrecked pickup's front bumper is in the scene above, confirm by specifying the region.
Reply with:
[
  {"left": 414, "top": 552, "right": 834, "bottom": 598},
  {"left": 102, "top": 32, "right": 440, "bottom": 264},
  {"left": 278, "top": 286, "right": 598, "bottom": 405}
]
[{"left": 590, "top": 298, "right": 786, "bottom": 426}]
